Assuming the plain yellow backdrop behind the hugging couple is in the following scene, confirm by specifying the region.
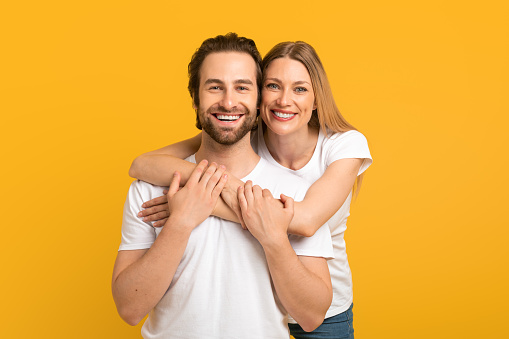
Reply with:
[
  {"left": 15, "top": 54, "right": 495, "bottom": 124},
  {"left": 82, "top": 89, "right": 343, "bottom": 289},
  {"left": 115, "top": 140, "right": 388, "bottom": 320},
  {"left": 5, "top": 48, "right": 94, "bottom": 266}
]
[{"left": 0, "top": 0, "right": 509, "bottom": 339}]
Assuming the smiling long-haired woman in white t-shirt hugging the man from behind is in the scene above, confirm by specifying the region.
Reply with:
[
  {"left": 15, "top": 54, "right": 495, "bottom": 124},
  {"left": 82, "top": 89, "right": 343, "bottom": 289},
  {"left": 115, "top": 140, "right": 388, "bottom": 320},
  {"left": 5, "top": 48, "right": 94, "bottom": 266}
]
[{"left": 130, "top": 42, "right": 372, "bottom": 339}]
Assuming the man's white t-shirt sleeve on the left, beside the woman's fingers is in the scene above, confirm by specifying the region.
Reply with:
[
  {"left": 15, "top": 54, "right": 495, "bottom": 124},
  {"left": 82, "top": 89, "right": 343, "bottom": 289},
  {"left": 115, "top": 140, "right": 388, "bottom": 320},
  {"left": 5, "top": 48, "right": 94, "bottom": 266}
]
[{"left": 118, "top": 180, "right": 156, "bottom": 251}]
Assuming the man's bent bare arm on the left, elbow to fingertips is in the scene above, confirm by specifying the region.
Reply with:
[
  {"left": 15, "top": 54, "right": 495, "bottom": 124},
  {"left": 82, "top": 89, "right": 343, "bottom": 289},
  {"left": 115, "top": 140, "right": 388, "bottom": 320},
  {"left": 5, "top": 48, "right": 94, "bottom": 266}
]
[{"left": 112, "top": 161, "right": 227, "bottom": 325}]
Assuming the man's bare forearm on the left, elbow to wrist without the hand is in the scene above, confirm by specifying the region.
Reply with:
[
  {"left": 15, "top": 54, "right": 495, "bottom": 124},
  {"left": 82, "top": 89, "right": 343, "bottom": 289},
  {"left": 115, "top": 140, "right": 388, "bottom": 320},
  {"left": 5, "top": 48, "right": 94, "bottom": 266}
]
[{"left": 112, "top": 220, "right": 191, "bottom": 325}]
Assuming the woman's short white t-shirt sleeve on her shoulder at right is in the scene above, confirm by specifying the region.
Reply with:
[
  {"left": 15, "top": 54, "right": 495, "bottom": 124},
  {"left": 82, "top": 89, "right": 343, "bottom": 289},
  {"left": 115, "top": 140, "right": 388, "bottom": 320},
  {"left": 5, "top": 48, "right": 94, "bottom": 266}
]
[{"left": 324, "top": 131, "right": 373, "bottom": 175}]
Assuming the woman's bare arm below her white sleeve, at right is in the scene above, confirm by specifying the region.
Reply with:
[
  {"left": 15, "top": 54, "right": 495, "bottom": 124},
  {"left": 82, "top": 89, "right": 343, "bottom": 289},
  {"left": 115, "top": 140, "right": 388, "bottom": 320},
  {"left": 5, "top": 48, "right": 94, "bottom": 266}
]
[{"left": 288, "top": 158, "right": 364, "bottom": 237}]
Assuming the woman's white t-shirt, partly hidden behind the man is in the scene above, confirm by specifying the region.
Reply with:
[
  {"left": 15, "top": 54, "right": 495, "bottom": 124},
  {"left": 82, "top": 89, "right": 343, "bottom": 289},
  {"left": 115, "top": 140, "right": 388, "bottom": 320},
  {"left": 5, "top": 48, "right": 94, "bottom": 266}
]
[{"left": 251, "top": 125, "right": 373, "bottom": 323}]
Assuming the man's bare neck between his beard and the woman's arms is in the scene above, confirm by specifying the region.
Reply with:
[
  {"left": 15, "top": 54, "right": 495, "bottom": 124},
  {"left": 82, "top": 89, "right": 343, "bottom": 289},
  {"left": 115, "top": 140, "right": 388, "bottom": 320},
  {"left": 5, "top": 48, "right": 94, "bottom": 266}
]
[{"left": 195, "top": 132, "right": 260, "bottom": 179}]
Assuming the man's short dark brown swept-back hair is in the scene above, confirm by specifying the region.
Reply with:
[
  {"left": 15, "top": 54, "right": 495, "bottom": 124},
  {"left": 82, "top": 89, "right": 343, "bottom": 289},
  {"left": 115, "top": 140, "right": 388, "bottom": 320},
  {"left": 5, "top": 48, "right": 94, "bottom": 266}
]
[{"left": 187, "top": 32, "right": 262, "bottom": 129}]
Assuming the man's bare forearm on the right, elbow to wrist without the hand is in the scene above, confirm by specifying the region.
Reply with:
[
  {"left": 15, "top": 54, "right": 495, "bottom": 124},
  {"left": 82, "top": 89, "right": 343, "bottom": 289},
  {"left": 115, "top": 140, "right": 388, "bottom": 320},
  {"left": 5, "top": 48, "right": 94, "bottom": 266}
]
[{"left": 264, "top": 239, "right": 332, "bottom": 331}]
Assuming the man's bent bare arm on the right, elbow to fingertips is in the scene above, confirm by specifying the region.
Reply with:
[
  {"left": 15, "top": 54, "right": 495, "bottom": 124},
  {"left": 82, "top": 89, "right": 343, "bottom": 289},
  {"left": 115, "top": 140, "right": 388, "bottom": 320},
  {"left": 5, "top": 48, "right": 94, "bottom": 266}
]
[{"left": 238, "top": 181, "right": 332, "bottom": 331}]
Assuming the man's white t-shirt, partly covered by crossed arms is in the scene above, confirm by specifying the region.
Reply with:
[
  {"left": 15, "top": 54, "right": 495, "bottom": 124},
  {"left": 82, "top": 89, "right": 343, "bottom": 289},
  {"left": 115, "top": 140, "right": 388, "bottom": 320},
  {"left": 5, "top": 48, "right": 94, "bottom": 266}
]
[{"left": 119, "top": 156, "right": 333, "bottom": 339}]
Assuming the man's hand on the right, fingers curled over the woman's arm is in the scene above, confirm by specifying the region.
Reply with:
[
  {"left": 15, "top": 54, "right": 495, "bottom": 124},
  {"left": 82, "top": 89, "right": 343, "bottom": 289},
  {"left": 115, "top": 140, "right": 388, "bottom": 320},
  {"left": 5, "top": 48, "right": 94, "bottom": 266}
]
[{"left": 238, "top": 181, "right": 293, "bottom": 246}]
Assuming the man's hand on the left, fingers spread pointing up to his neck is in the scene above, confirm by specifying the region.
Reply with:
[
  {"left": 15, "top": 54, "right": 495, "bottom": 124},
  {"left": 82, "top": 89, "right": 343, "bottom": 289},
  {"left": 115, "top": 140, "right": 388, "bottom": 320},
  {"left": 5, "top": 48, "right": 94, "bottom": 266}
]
[{"left": 167, "top": 160, "right": 227, "bottom": 228}]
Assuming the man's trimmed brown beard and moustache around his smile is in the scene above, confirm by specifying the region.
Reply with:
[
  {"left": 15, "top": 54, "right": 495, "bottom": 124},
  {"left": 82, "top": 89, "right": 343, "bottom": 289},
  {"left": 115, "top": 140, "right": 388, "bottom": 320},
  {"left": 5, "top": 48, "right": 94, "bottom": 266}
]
[{"left": 198, "top": 106, "right": 256, "bottom": 145}]
